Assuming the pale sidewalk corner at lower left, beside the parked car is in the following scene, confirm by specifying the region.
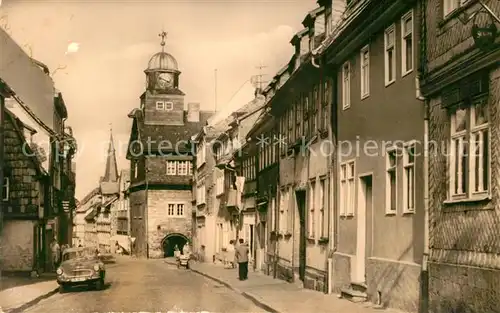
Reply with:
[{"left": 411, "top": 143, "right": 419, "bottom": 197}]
[{"left": 0, "top": 280, "right": 58, "bottom": 313}]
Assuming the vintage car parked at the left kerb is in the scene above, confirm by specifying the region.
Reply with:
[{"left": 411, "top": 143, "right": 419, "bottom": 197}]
[{"left": 57, "top": 248, "right": 106, "bottom": 292}]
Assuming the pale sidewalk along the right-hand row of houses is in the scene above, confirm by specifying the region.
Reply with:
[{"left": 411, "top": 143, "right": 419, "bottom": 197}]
[{"left": 170, "top": 260, "right": 404, "bottom": 313}]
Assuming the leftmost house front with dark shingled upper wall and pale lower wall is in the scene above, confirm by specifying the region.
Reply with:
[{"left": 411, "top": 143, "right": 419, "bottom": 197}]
[{"left": 2, "top": 110, "right": 49, "bottom": 272}]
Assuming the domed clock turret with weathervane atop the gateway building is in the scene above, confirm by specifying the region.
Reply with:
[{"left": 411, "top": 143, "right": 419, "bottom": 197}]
[{"left": 142, "top": 32, "right": 184, "bottom": 126}]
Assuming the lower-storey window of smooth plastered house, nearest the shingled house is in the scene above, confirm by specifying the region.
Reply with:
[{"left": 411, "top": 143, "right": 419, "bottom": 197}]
[{"left": 403, "top": 142, "right": 416, "bottom": 213}]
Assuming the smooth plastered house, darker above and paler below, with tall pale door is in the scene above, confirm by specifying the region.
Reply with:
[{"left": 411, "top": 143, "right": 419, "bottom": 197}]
[{"left": 320, "top": 0, "right": 425, "bottom": 312}]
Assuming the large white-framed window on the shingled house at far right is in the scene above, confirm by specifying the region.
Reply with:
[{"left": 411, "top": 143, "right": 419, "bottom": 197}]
[{"left": 449, "top": 99, "right": 491, "bottom": 200}]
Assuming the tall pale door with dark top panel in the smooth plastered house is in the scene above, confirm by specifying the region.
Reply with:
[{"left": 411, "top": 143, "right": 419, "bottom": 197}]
[{"left": 352, "top": 174, "right": 372, "bottom": 283}]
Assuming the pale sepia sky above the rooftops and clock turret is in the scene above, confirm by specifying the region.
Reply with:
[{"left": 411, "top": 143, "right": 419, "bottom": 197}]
[{"left": 0, "top": 0, "right": 316, "bottom": 199}]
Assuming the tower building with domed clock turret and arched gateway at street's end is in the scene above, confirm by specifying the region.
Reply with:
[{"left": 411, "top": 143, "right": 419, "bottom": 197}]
[{"left": 127, "top": 34, "right": 211, "bottom": 258}]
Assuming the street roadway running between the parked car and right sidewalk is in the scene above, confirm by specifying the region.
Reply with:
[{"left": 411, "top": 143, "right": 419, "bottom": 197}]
[{"left": 20, "top": 258, "right": 265, "bottom": 313}]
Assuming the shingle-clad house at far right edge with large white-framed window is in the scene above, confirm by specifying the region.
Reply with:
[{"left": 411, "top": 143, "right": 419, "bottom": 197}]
[{"left": 421, "top": 0, "right": 500, "bottom": 313}]
